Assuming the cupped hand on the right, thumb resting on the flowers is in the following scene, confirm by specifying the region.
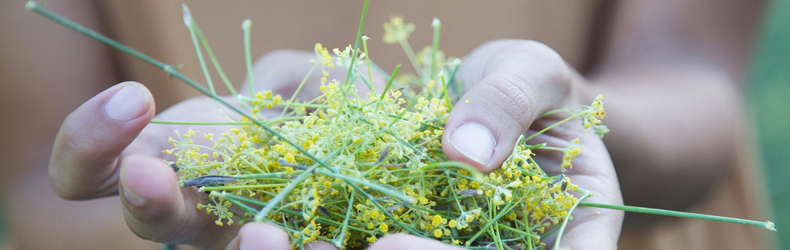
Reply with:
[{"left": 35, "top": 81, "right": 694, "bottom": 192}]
[{"left": 388, "top": 40, "right": 623, "bottom": 250}]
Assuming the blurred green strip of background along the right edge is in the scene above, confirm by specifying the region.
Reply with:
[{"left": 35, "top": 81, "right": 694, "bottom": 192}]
[{"left": 747, "top": 0, "right": 790, "bottom": 249}]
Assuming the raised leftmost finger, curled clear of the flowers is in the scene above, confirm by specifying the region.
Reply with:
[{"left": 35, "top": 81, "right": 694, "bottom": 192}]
[{"left": 49, "top": 82, "right": 155, "bottom": 200}]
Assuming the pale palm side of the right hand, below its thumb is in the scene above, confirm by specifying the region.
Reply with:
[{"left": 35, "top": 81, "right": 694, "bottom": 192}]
[{"left": 527, "top": 117, "right": 623, "bottom": 249}]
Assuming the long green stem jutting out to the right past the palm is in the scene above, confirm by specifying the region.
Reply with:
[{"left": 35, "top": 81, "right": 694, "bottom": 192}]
[{"left": 579, "top": 202, "right": 776, "bottom": 231}]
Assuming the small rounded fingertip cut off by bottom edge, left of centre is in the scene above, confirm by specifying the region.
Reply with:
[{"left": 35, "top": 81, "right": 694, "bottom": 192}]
[{"left": 226, "top": 223, "right": 300, "bottom": 250}]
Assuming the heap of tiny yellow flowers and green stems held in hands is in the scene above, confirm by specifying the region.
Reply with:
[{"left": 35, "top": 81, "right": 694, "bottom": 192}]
[{"left": 165, "top": 18, "right": 605, "bottom": 249}]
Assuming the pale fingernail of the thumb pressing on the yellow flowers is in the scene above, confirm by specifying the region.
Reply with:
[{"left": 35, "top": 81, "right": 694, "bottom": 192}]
[{"left": 450, "top": 122, "right": 496, "bottom": 166}]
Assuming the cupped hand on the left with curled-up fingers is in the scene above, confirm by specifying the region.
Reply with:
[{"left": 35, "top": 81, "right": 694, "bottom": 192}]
[{"left": 49, "top": 51, "right": 372, "bottom": 249}]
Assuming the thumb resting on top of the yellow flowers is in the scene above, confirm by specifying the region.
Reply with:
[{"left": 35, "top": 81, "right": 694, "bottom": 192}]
[{"left": 442, "top": 40, "right": 572, "bottom": 172}]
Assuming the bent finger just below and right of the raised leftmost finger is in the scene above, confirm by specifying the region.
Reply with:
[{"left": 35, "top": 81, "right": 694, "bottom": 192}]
[{"left": 120, "top": 155, "right": 238, "bottom": 248}]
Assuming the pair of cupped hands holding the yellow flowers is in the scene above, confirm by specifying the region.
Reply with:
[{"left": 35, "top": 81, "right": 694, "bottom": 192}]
[{"left": 49, "top": 40, "right": 623, "bottom": 250}]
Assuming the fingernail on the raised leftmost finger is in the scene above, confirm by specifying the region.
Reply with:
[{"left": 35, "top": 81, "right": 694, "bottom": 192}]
[{"left": 104, "top": 83, "right": 149, "bottom": 121}]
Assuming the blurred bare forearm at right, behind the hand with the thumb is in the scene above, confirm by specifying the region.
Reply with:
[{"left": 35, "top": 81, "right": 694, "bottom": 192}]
[{"left": 582, "top": 61, "right": 741, "bottom": 212}]
